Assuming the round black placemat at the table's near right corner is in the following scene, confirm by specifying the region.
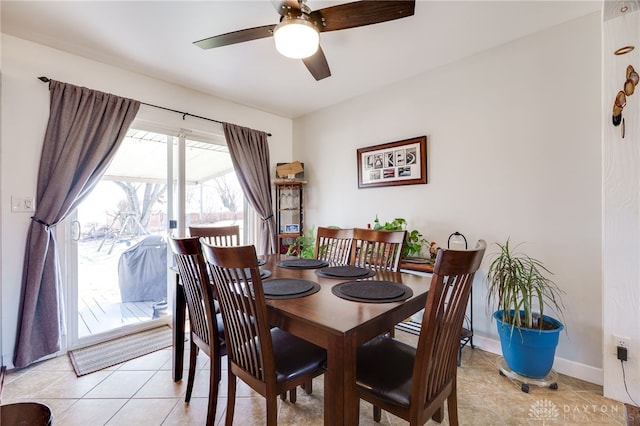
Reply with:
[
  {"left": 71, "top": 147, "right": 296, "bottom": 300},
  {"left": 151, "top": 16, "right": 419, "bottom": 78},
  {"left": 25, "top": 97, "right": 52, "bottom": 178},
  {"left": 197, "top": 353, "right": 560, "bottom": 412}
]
[{"left": 331, "top": 281, "right": 413, "bottom": 303}]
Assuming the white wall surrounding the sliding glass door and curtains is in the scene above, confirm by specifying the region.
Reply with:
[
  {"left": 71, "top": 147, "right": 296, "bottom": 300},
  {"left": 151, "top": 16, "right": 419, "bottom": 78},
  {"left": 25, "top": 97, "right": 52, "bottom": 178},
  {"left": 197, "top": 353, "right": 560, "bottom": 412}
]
[{"left": 0, "top": 34, "right": 292, "bottom": 367}]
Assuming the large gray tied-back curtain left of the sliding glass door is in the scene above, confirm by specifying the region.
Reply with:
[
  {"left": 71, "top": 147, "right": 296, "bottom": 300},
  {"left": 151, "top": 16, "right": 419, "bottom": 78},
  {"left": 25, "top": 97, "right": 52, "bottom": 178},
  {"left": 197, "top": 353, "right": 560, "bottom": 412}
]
[{"left": 14, "top": 80, "right": 140, "bottom": 367}]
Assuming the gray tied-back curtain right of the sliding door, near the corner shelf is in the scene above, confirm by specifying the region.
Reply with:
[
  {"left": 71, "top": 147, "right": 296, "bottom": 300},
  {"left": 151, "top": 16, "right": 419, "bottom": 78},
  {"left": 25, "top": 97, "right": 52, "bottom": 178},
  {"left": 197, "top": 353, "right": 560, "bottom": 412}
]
[{"left": 223, "top": 123, "right": 276, "bottom": 254}]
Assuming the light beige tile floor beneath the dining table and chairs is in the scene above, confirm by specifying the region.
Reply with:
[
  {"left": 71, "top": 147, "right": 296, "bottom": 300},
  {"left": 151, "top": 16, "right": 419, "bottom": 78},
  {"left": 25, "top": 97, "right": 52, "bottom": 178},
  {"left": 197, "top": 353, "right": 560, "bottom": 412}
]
[{"left": 2, "top": 331, "right": 626, "bottom": 426}]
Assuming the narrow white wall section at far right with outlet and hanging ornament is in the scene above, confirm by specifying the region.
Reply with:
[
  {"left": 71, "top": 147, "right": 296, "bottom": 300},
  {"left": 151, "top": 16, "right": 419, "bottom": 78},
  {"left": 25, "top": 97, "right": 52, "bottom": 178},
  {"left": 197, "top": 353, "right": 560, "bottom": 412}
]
[{"left": 602, "top": 8, "right": 640, "bottom": 402}]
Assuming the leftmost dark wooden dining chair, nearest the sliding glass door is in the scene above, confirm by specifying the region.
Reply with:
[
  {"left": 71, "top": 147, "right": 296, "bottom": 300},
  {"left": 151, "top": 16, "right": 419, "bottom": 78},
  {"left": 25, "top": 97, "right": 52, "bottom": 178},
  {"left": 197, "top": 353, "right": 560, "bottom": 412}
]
[{"left": 169, "top": 237, "right": 226, "bottom": 425}]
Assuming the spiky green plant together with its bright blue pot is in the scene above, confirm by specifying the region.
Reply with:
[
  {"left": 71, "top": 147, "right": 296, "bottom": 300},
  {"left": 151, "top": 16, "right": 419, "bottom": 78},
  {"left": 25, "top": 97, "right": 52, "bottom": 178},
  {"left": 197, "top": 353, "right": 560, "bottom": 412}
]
[{"left": 487, "top": 239, "right": 564, "bottom": 378}]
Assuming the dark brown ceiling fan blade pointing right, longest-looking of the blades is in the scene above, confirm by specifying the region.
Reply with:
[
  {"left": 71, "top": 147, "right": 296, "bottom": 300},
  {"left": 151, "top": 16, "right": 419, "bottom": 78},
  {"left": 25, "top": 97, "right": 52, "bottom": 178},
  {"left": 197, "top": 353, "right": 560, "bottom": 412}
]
[{"left": 309, "top": 0, "right": 416, "bottom": 32}]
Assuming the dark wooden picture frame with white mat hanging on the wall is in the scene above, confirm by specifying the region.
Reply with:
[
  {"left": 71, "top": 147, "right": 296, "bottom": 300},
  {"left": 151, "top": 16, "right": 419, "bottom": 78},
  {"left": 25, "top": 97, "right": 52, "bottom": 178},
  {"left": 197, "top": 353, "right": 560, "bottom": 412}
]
[{"left": 357, "top": 136, "right": 427, "bottom": 188}]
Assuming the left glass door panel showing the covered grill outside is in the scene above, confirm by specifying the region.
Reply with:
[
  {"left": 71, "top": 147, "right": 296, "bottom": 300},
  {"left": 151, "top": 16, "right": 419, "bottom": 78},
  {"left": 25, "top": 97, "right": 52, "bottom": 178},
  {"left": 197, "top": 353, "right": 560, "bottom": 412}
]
[{"left": 70, "top": 129, "right": 174, "bottom": 343}]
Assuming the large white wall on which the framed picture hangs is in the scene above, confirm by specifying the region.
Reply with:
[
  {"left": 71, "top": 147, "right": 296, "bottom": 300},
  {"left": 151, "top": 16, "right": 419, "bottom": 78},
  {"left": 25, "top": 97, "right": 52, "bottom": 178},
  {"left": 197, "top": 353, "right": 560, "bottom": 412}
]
[{"left": 294, "top": 14, "right": 603, "bottom": 383}]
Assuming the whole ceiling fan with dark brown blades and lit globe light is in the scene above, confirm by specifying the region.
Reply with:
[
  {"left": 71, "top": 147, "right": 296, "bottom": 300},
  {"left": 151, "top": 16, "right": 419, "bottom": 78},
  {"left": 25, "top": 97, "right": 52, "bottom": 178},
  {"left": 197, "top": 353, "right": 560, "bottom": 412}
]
[{"left": 193, "top": 0, "right": 415, "bottom": 80}]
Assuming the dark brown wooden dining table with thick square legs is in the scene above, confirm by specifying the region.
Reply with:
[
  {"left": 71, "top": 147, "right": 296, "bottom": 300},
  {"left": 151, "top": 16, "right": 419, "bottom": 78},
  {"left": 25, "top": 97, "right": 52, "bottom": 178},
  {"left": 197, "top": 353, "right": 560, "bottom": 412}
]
[{"left": 173, "top": 254, "right": 431, "bottom": 425}]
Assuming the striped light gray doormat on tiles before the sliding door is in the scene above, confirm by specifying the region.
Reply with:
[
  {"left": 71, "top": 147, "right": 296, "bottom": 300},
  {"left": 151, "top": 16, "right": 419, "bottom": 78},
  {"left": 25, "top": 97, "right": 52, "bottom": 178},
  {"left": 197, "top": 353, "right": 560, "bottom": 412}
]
[{"left": 69, "top": 326, "right": 173, "bottom": 377}]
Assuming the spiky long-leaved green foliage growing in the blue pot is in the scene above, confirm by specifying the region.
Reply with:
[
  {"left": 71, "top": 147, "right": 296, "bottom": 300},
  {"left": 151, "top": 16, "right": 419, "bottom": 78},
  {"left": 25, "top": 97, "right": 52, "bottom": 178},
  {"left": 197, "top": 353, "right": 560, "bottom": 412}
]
[{"left": 487, "top": 239, "right": 565, "bottom": 332}]
